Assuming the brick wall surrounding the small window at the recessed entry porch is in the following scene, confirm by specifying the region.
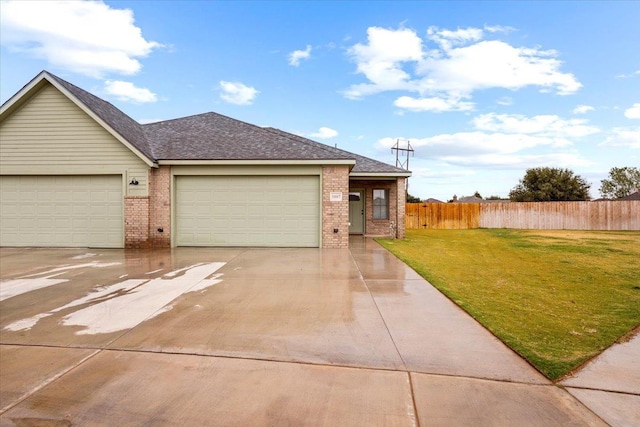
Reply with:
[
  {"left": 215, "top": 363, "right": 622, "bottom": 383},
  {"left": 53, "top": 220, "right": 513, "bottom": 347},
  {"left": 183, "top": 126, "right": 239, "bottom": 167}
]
[{"left": 349, "top": 178, "right": 405, "bottom": 238}]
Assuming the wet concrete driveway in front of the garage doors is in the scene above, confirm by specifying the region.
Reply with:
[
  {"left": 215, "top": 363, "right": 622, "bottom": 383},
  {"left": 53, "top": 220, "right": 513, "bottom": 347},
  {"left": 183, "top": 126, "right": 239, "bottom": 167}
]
[{"left": 0, "top": 238, "right": 606, "bottom": 426}]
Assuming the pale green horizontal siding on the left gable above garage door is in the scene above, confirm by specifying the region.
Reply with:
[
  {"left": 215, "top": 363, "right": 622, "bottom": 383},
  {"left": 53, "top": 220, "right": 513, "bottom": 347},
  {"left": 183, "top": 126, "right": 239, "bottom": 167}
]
[{"left": 0, "top": 84, "right": 149, "bottom": 196}]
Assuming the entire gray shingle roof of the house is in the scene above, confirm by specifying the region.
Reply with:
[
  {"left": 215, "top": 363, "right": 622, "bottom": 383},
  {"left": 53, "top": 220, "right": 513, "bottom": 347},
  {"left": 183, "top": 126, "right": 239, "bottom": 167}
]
[{"left": 25, "top": 71, "right": 408, "bottom": 174}]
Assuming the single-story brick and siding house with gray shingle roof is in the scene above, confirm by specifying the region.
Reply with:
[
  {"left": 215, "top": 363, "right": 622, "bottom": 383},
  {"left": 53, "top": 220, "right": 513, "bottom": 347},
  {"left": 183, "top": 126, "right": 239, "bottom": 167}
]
[{"left": 0, "top": 71, "right": 411, "bottom": 248}]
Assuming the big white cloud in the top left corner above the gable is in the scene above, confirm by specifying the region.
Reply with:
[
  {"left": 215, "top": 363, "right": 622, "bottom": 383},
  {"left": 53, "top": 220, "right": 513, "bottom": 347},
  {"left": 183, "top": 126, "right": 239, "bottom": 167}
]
[{"left": 0, "top": 0, "right": 162, "bottom": 77}]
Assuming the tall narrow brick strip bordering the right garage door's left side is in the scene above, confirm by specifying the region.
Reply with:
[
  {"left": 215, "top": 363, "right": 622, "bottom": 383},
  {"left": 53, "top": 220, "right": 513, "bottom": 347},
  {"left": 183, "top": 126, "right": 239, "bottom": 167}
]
[{"left": 147, "top": 166, "right": 171, "bottom": 248}]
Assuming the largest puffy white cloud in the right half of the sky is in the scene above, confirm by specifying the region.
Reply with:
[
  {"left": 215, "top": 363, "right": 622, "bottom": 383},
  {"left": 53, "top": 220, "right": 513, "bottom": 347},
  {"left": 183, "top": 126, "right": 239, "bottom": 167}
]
[{"left": 344, "top": 27, "right": 582, "bottom": 103}]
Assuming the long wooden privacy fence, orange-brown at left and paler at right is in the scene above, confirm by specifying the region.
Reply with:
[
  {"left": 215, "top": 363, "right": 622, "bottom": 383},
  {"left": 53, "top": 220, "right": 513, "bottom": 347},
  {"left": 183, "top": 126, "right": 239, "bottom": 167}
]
[{"left": 405, "top": 200, "right": 640, "bottom": 230}]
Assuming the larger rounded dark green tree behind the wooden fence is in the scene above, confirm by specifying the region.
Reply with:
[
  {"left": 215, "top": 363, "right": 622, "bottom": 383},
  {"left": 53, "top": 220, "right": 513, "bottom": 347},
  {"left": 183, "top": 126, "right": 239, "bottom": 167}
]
[{"left": 509, "top": 167, "right": 591, "bottom": 202}]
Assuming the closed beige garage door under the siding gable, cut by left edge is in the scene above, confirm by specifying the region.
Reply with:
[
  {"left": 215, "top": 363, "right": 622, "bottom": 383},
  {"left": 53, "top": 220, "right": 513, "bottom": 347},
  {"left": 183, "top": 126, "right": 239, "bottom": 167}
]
[{"left": 0, "top": 175, "right": 124, "bottom": 248}]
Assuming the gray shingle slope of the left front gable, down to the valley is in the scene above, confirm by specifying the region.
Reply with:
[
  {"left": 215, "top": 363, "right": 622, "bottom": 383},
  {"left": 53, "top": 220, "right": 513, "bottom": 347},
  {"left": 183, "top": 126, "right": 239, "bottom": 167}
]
[{"left": 47, "top": 73, "right": 153, "bottom": 159}]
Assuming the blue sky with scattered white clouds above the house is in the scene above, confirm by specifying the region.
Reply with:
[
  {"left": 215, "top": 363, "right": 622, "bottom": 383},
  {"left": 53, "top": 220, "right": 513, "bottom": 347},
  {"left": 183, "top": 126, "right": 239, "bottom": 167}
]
[{"left": 0, "top": 1, "right": 640, "bottom": 200}]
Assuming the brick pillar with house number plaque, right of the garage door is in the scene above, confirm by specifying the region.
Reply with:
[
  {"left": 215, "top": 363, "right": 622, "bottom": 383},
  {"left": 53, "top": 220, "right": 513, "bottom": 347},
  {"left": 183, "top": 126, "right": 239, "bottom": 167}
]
[{"left": 322, "top": 166, "right": 349, "bottom": 248}]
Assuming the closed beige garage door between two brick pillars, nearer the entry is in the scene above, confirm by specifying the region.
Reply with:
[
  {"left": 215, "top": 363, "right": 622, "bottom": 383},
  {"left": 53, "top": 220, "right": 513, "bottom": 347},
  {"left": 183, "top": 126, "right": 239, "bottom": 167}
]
[{"left": 175, "top": 176, "right": 320, "bottom": 247}]
